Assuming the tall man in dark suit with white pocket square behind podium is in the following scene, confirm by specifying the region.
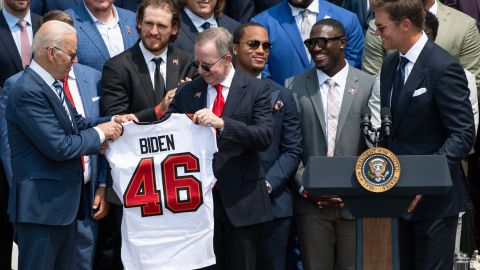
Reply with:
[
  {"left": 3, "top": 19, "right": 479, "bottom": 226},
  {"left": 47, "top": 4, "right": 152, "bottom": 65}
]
[{"left": 374, "top": 0, "right": 475, "bottom": 270}]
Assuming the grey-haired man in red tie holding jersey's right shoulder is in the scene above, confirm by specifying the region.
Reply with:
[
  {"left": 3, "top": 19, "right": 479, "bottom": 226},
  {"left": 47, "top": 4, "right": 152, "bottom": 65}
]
[{"left": 169, "top": 27, "right": 273, "bottom": 270}]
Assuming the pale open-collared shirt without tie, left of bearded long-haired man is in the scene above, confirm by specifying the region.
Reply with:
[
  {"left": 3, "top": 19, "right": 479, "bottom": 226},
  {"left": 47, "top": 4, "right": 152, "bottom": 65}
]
[{"left": 83, "top": 3, "right": 125, "bottom": 57}]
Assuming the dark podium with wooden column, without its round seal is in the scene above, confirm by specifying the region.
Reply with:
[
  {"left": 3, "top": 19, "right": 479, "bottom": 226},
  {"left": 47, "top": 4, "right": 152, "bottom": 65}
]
[{"left": 303, "top": 155, "right": 452, "bottom": 270}]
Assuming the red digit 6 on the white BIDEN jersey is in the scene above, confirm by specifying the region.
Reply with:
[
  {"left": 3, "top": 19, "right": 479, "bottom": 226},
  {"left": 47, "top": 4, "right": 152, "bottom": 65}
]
[{"left": 162, "top": 153, "right": 203, "bottom": 213}]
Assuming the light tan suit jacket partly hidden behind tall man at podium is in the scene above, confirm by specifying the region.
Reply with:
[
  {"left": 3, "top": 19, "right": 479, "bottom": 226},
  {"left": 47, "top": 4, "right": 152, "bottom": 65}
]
[{"left": 362, "top": 0, "right": 480, "bottom": 93}]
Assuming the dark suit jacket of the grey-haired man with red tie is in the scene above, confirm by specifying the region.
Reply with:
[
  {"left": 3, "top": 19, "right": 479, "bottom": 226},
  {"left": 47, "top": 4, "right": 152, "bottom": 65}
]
[{"left": 169, "top": 71, "right": 273, "bottom": 227}]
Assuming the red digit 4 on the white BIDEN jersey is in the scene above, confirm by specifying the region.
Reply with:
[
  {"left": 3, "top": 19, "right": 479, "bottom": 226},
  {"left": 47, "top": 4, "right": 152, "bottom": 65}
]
[{"left": 123, "top": 157, "right": 162, "bottom": 217}]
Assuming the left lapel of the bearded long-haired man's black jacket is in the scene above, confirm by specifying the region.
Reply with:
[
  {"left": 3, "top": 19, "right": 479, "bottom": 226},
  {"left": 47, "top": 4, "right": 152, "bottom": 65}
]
[{"left": 127, "top": 43, "right": 155, "bottom": 106}]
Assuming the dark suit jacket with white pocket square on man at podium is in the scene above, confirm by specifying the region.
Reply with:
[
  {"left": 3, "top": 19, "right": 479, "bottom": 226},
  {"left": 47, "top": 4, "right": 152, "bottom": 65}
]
[{"left": 380, "top": 41, "right": 475, "bottom": 219}]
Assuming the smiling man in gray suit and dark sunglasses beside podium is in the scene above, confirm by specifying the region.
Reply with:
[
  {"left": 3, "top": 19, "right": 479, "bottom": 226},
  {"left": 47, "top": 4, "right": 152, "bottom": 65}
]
[{"left": 287, "top": 19, "right": 374, "bottom": 270}]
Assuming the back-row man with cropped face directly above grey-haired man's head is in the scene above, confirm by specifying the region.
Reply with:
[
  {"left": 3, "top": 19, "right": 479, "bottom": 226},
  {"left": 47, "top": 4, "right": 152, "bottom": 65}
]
[{"left": 172, "top": 0, "right": 240, "bottom": 53}]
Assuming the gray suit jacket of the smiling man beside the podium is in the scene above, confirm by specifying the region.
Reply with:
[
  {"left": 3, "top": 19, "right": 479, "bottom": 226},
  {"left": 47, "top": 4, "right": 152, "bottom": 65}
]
[{"left": 286, "top": 66, "right": 375, "bottom": 218}]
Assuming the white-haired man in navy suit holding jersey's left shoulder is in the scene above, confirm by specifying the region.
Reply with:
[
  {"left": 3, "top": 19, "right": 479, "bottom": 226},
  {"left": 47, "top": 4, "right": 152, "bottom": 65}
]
[{"left": 6, "top": 21, "right": 132, "bottom": 269}]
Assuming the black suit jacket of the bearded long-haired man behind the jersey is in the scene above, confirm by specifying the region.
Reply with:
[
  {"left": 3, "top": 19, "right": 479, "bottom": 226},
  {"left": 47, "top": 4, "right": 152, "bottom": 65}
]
[{"left": 101, "top": 42, "right": 197, "bottom": 122}]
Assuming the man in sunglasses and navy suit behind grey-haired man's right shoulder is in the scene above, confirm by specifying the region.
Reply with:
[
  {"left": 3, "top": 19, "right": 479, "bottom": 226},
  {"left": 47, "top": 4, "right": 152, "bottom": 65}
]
[{"left": 233, "top": 22, "right": 302, "bottom": 270}]
